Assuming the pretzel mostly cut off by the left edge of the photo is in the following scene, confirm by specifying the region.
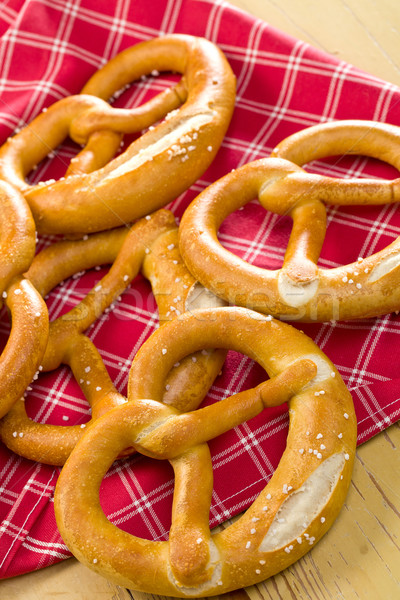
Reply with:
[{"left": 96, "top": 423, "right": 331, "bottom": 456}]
[{"left": 0, "top": 181, "right": 49, "bottom": 418}]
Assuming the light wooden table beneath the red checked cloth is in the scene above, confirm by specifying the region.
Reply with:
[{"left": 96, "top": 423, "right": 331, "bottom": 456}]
[{"left": 0, "top": 0, "right": 400, "bottom": 600}]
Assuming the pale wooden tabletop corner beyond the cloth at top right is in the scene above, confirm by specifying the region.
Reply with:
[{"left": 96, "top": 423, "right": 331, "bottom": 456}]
[{"left": 230, "top": 0, "right": 400, "bottom": 85}]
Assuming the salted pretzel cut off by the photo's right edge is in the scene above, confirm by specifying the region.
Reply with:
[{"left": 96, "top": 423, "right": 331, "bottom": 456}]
[{"left": 180, "top": 121, "right": 400, "bottom": 321}]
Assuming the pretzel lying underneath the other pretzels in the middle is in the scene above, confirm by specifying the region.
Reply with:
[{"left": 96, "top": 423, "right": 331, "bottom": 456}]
[{"left": 0, "top": 210, "right": 225, "bottom": 465}]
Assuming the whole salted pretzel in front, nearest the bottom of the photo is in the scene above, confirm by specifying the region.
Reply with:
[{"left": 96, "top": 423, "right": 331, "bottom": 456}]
[{"left": 55, "top": 307, "right": 356, "bottom": 598}]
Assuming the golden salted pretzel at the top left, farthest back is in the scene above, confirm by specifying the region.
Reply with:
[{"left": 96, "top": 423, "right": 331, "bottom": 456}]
[{"left": 0, "top": 35, "right": 235, "bottom": 234}]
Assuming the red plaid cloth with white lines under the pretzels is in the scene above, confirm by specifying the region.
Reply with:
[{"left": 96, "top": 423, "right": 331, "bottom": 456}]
[{"left": 0, "top": 0, "right": 400, "bottom": 578}]
